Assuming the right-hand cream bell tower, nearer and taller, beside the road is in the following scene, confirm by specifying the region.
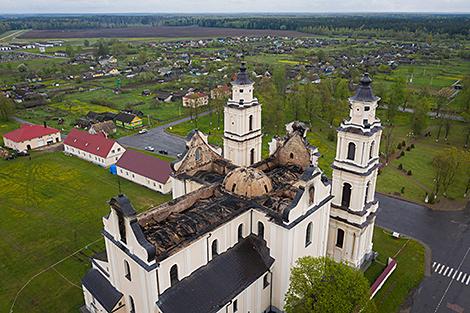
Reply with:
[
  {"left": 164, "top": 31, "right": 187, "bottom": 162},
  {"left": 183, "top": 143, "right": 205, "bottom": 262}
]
[{"left": 328, "top": 73, "right": 382, "bottom": 268}]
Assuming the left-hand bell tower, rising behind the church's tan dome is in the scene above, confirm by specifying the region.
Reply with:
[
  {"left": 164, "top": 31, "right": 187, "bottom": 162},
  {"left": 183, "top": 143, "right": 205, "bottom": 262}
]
[{"left": 224, "top": 62, "right": 262, "bottom": 166}]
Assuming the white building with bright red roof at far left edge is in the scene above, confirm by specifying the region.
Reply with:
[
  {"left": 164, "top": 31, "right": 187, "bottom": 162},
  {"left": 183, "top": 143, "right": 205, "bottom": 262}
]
[{"left": 3, "top": 123, "right": 61, "bottom": 151}]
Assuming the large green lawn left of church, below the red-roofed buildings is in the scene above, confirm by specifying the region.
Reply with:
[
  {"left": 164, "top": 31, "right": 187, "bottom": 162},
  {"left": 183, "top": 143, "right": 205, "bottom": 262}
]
[{"left": 0, "top": 152, "right": 170, "bottom": 312}]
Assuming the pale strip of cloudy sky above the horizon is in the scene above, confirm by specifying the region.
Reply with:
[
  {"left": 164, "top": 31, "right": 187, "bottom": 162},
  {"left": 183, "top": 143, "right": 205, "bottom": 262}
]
[{"left": 0, "top": 0, "right": 470, "bottom": 14}]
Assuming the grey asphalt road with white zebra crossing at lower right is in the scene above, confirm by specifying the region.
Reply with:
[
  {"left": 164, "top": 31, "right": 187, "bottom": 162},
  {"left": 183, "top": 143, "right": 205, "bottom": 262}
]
[{"left": 377, "top": 194, "right": 470, "bottom": 313}]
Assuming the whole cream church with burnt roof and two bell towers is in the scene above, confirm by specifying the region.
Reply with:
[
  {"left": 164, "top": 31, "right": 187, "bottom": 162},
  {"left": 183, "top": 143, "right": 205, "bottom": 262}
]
[{"left": 82, "top": 63, "right": 382, "bottom": 313}]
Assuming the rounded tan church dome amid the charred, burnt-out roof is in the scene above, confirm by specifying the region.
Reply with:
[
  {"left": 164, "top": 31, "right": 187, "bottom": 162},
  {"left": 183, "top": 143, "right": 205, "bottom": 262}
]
[{"left": 223, "top": 167, "right": 273, "bottom": 198}]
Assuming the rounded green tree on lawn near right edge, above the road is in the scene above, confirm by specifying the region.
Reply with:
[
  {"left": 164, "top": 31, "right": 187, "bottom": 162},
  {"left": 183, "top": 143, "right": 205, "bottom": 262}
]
[{"left": 432, "top": 147, "right": 462, "bottom": 197}]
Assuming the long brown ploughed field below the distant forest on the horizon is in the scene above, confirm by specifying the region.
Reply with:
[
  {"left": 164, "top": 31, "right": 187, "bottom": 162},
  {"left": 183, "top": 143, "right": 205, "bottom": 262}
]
[{"left": 19, "top": 26, "right": 309, "bottom": 39}]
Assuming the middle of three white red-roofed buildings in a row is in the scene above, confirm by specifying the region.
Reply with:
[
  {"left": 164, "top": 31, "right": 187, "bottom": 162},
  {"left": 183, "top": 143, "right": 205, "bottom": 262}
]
[{"left": 64, "top": 128, "right": 126, "bottom": 167}]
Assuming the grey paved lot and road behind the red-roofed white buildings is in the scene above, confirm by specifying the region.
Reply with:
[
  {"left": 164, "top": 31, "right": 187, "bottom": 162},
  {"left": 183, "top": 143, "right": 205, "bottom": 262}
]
[{"left": 118, "top": 111, "right": 210, "bottom": 156}]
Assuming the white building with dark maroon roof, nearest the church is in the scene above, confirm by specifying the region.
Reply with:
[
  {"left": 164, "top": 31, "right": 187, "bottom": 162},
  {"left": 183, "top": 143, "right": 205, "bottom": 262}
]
[{"left": 116, "top": 150, "right": 172, "bottom": 194}]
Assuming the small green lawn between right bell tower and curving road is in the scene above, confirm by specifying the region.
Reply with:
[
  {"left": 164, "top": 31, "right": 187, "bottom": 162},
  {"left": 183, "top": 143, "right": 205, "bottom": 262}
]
[{"left": 365, "top": 227, "right": 425, "bottom": 313}]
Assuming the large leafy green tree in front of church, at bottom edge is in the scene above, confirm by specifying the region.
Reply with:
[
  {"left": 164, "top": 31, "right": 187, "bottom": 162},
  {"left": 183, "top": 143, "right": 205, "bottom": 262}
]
[{"left": 284, "top": 257, "right": 377, "bottom": 313}]
